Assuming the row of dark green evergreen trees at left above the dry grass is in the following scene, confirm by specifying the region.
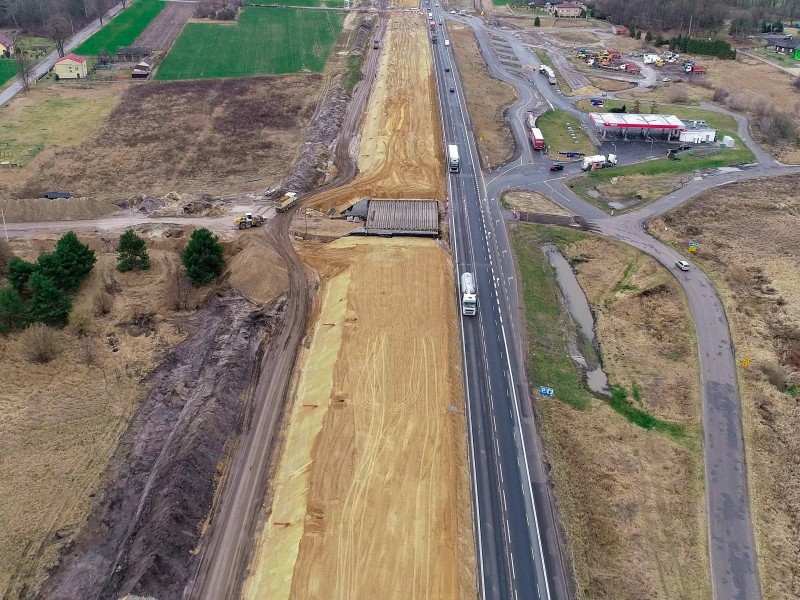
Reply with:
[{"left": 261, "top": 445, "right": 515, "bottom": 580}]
[{"left": 0, "top": 229, "right": 225, "bottom": 333}]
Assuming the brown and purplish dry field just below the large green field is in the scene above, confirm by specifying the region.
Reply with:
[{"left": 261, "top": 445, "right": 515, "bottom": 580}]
[{"left": 8, "top": 75, "right": 323, "bottom": 200}]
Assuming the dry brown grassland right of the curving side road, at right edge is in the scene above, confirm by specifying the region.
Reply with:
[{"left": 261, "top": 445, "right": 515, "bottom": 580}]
[{"left": 651, "top": 176, "right": 800, "bottom": 600}]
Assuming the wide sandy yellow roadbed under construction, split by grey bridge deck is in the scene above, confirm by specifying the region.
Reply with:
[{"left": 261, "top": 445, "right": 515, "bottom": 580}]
[{"left": 245, "top": 9, "right": 475, "bottom": 598}]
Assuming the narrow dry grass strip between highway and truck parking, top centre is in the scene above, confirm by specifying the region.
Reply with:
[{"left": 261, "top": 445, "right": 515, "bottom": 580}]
[{"left": 448, "top": 25, "right": 517, "bottom": 166}]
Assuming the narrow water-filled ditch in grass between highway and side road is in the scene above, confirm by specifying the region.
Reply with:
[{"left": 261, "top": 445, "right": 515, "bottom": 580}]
[{"left": 542, "top": 244, "right": 610, "bottom": 396}]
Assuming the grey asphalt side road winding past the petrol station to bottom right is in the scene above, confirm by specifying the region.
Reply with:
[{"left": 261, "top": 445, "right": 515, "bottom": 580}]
[{"left": 450, "top": 14, "right": 800, "bottom": 600}]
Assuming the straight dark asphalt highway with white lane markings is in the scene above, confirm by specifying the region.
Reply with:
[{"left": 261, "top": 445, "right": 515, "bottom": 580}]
[{"left": 428, "top": 7, "right": 569, "bottom": 599}]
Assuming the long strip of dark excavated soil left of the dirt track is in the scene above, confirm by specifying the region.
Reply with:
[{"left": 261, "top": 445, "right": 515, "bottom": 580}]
[{"left": 39, "top": 292, "right": 285, "bottom": 600}]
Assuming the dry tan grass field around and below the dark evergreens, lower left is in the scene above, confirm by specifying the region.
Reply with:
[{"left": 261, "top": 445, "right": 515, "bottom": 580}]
[{"left": 0, "top": 233, "right": 183, "bottom": 598}]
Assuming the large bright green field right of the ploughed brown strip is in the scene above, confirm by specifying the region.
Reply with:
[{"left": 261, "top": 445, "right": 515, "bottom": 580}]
[{"left": 156, "top": 8, "right": 344, "bottom": 79}]
